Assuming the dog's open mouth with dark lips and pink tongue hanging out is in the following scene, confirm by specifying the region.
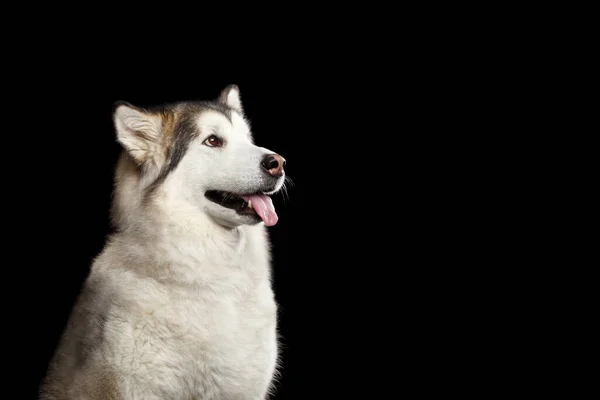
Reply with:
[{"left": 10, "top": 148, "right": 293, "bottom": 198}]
[{"left": 204, "top": 190, "right": 279, "bottom": 226}]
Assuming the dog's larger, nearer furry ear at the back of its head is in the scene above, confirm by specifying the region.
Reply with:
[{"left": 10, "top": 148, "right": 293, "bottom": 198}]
[{"left": 113, "top": 102, "right": 165, "bottom": 168}]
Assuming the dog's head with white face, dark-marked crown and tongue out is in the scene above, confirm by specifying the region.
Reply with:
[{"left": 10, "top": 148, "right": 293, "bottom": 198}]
[{"left": 114, "top": 85, "right": 286, "bottom": 227}]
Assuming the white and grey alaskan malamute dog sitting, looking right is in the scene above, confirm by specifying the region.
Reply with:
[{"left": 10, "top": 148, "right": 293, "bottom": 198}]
[{"left": 40, "top": 85, "right": 286, "bottom": 400}]
